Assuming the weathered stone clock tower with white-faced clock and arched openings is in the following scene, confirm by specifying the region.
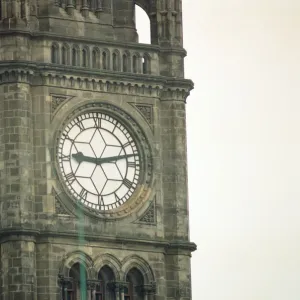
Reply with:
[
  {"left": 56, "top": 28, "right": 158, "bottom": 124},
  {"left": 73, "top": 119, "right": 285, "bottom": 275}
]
[{"left": 0, "top": 0, "right": 196, "bottom": 300}]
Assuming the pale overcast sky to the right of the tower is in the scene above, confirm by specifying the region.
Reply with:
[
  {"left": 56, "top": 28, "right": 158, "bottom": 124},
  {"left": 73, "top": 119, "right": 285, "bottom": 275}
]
[{"left": 138, "top": 0, "right": 300, "bottom": 300}]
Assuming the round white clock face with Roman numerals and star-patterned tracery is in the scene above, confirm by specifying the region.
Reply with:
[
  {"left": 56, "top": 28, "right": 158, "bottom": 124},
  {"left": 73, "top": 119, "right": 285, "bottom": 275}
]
[{"left": 58, "top": 112, "right": 140, "bottom": 211}]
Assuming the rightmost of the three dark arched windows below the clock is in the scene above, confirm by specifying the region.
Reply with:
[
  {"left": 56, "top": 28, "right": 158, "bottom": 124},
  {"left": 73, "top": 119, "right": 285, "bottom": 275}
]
[{"left": 124, "top": 268, "right": 144, "bottom": 300}]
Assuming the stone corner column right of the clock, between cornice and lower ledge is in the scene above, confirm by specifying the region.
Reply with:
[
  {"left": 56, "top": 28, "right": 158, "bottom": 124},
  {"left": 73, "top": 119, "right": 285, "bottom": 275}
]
[{"left": 161, "top": 98, "right": 189, "bottom": 241}]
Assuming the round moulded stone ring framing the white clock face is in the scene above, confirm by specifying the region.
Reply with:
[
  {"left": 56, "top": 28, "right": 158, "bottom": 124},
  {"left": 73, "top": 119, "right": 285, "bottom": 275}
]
[{"left": 51, "top": 102, "right": 154, "bottom": 219}]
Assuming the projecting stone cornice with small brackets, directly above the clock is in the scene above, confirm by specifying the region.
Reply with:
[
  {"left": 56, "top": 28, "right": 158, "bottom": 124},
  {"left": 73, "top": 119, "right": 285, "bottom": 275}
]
[{"left": 0, "top": 61, "right": 193, "bottom": 102}]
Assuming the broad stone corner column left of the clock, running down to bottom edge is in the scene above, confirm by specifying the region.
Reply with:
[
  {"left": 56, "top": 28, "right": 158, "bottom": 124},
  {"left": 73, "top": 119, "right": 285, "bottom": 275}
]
[{"left": 0, "top": 70, "right": 37, "bottom": 300}]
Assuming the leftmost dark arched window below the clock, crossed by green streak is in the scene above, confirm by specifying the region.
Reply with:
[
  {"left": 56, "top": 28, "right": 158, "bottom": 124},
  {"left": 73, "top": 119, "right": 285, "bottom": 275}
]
[{"left": 66, "top": 263, "right": 88, "bottom": 300}]
